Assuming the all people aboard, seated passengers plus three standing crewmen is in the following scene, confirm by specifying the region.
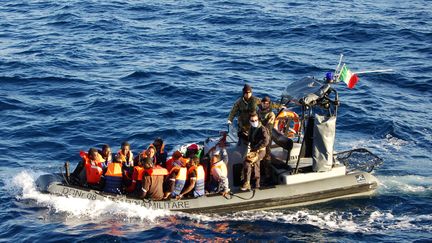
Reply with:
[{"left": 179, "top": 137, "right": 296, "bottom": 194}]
[{"left": 71, "top": 84, "right": 282, "bottom": 200}]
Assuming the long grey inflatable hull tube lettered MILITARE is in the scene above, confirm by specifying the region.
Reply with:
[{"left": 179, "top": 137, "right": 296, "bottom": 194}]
[{"left": 36, "top": 172, "right": 378, "bottom": 213}]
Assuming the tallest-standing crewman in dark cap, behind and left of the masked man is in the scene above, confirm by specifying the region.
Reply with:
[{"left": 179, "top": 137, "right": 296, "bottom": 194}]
[{"left": 228, "top": 84, "right": 260, "bottom": 141}]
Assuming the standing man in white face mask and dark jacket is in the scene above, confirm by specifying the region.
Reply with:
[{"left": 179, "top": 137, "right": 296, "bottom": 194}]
[{"left": 240, "top": 112, "right": 270, "bottom": 191}]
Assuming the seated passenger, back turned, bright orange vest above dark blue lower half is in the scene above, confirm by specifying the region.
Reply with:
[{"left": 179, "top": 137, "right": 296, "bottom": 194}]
[{"left": 103, "top": 156, "right": 123, "bottom": 194}]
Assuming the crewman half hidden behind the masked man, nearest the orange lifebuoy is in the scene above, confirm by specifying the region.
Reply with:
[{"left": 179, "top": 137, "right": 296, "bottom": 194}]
[{"left": 258, "top": 96, "right": 276, "bottom": 183}]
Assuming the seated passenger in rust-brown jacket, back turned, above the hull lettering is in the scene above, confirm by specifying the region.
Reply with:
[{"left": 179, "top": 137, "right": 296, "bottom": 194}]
[{"left": 140, "top": 158, "right": 168, "bottom": 200}]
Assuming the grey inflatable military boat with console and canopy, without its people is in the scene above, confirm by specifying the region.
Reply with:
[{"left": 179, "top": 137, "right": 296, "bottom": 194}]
[{"left": 36, "top": 78, "right": 382, "bottom": 213}]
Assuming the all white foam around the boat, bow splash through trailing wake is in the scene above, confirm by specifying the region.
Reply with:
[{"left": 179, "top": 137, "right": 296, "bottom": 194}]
[{"left": 5, "top": 171, "right": 432, "bottom": 232}]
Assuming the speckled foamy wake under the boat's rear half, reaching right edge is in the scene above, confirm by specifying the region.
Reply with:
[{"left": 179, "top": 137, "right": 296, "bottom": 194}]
[{"left": 184, "top": 210, "right": 432, "bottom": 233}]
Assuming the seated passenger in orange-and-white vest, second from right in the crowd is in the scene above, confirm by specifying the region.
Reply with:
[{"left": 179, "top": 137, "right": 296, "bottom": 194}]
[{"left": 176, "top": 156, "right": 205, "bottom": 200}]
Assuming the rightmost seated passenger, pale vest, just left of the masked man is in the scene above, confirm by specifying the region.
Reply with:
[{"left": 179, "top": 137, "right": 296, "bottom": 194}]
[{"left": 210, "top": 151, "right": 230, "bottom": 196}]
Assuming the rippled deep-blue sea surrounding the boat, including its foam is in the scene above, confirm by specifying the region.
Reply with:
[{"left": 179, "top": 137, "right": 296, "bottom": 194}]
[{"left": 0, "top": 0, "right": 432, "bottom": 242}]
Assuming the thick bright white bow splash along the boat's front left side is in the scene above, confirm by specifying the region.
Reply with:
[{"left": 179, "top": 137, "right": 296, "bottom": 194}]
[{"left": 6, "top": 171, "right": 171, "bottom": 221}]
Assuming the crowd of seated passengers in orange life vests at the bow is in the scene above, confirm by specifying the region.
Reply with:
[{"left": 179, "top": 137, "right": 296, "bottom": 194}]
[{"left": 71, "top": 138, "right": 230, "bottom": 200}]
